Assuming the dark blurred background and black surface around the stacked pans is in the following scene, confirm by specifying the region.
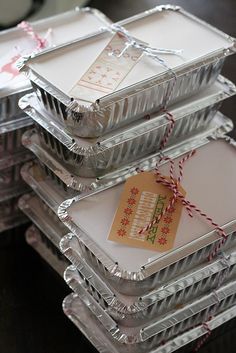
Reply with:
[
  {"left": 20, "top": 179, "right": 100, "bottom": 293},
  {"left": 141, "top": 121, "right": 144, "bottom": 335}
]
[{"left": 0, "top": 0, "right": 236, "bottom": 353}]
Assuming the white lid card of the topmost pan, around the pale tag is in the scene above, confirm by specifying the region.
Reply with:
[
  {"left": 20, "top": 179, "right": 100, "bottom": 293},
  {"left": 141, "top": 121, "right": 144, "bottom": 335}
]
[{"left": 30, "top": 11, "right": 232, "bottom": 98}]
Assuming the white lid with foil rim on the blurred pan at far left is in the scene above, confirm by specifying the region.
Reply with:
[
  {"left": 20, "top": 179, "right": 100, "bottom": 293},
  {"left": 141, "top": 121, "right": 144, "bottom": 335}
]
[{"left": 0, "top": 7, "right": 111, "bottom": 99}]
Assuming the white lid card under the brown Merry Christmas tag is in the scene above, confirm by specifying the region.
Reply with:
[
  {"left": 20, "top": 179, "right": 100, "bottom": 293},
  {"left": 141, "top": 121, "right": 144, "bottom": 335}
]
[{"left": 68, "top": 140, "right": 236, "bottom": 271}]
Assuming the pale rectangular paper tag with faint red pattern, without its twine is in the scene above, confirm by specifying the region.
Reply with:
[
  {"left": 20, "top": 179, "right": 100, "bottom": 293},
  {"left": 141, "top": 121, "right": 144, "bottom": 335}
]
[{"left": 70, "top": 34, "right": 142, "bottom": 101}]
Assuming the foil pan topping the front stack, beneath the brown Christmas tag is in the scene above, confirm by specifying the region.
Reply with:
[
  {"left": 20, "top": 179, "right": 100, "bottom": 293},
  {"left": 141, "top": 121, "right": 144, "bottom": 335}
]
[{"left": 58, "top": 137, "right": 236, "bottom": 295}]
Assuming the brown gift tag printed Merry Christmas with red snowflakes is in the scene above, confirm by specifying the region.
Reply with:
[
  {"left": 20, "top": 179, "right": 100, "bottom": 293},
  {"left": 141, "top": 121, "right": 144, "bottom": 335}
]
[{"left": 108, "top": 172, "right": 186, "bottom": 252}]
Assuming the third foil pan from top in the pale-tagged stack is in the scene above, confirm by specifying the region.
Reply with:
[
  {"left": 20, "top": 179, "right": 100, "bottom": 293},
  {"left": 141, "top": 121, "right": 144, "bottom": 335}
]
[{"left": 22, "top": 113, "right": 233, "bottom": 191}]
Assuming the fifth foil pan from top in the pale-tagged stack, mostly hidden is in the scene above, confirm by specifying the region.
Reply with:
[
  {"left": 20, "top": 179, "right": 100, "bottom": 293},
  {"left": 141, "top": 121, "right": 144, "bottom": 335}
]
[{"left": 18, "top": 194, "right": 68, "bottom": 246}]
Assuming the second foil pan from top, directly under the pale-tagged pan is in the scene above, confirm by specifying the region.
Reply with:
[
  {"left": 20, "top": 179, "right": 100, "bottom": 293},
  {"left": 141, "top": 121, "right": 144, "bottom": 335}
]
[{"left": 19, "top": 76, "right": 236, "bottom": 177}]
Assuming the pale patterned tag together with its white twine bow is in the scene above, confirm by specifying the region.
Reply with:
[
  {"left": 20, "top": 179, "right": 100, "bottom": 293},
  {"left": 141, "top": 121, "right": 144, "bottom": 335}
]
[{"left": 70, "top": 24, "right": 182, "bottom": 101}]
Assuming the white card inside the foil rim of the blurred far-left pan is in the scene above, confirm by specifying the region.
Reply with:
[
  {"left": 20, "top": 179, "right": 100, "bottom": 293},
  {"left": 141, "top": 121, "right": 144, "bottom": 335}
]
[{"left": 0, "top": 10, "right": 110, "bottom": 92}]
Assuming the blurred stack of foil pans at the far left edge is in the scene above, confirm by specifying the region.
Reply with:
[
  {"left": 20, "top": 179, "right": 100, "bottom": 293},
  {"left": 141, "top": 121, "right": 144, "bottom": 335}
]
[{"left": 0, "top": 8, "right": 110, "bottom": 232}]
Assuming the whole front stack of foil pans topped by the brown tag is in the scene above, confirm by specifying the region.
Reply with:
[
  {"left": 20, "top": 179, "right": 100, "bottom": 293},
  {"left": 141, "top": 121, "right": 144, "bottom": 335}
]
[{"left": 58, "top": 138, "right": 236, "bottom": 352}]
